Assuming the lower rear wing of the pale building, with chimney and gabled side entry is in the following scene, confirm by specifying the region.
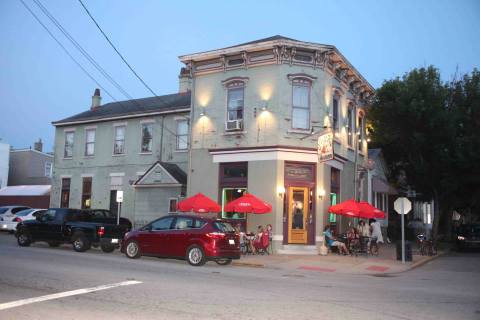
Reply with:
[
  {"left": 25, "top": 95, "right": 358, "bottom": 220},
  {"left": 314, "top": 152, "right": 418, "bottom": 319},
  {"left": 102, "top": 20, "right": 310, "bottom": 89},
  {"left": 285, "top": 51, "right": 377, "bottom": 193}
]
[{"left": 51, "top": 89, "right": 190, "bottom": 225}]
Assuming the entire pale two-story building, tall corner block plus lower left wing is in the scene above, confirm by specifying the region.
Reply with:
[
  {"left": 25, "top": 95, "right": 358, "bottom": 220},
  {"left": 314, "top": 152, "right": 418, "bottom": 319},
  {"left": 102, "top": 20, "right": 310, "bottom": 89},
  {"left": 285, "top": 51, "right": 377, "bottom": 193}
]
[{"left": 51, "top": 36, "right": 373, "bottom": 252}]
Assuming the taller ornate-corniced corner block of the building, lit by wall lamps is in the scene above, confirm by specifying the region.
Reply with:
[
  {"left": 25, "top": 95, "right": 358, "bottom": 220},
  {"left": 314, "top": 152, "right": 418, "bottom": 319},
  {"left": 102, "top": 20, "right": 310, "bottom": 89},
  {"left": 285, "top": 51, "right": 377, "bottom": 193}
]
[{"left": 180, "top": 36, "right": 374, "bottom": 252}]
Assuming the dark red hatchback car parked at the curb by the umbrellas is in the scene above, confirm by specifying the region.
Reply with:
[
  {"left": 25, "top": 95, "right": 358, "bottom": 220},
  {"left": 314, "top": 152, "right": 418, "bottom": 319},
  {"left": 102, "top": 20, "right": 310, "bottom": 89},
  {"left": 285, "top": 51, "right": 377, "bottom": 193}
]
[{"left": 121, "top": 215, "right": 240, "bottom": 266}]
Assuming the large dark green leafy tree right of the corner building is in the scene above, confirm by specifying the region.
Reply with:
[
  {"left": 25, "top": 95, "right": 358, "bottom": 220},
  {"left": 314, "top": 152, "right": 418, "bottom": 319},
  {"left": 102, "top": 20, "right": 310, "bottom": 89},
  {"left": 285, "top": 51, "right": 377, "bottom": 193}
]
[{"left": 368, "top": 66, "right": 480, "bottom": 238}]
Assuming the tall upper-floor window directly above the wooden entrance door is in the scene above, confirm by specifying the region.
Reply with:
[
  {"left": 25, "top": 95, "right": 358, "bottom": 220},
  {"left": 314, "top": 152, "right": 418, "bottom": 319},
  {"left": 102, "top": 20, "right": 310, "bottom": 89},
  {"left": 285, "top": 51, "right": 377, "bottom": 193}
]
[{"left": 292, "top": 79, "right": 311, "bottom": 130}]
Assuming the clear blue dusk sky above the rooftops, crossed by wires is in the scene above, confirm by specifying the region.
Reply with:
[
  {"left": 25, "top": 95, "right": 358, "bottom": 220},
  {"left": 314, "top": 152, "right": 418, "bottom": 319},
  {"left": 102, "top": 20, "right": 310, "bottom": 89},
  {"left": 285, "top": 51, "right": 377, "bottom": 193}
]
[{"left": 0, "top": 0, "right": 480, "bottom": 151}]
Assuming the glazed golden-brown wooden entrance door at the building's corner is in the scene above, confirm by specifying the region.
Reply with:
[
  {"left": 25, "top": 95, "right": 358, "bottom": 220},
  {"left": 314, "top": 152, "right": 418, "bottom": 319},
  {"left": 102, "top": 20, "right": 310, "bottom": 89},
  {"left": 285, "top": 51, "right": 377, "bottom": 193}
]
[{"left": 288, "top": 187, "right": 308, "bottom": 244}]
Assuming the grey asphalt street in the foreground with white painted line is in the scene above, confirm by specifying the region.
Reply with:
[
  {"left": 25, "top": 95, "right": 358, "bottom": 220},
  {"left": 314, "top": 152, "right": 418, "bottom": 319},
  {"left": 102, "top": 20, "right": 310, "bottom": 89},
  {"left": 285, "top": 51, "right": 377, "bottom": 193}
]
[{"left": 0, "top": 233, "right": 480, "bottom": 320}]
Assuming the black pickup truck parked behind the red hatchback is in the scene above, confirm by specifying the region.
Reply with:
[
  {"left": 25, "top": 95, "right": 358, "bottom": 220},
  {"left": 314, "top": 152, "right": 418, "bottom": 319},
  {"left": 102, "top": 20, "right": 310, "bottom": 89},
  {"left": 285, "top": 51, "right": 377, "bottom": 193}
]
[{"left": 15, "top": 208, "right": 132, "bottom": 252}]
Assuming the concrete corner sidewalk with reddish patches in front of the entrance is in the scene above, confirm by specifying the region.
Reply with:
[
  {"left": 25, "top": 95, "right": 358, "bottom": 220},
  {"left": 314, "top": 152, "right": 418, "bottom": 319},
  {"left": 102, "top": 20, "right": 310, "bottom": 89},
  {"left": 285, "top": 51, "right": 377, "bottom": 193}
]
[{"left": 233, "top": 244, "right": 443, "bottom": 274}]
